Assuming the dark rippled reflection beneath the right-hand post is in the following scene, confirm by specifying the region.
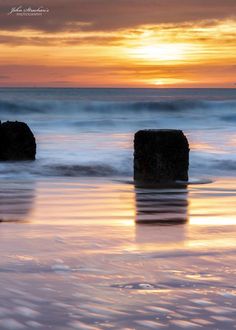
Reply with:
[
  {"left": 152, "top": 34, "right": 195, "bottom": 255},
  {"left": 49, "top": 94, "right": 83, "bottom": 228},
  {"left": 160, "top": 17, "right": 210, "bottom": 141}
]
[{"left": 135, "top": 185, "right": 188, "bottom": 225}]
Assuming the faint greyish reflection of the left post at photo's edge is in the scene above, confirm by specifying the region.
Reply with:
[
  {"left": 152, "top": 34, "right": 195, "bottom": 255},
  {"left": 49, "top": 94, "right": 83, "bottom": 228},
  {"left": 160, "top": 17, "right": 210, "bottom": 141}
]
[{"left": 0, "top": 181, "right": 35, "bottom": 222}]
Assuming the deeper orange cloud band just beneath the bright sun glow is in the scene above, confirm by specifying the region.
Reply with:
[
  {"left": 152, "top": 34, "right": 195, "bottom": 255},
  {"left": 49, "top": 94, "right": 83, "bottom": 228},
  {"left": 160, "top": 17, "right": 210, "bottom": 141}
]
[{"left": 0, "top": 63, "right": 236, "bottom": 84}]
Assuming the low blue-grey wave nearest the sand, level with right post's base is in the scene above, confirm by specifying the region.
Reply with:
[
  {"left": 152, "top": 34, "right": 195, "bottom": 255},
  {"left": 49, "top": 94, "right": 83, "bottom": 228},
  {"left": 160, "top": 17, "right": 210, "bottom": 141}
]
[{"left": 0, "top": 158, "right": 236, "bottom": 180}]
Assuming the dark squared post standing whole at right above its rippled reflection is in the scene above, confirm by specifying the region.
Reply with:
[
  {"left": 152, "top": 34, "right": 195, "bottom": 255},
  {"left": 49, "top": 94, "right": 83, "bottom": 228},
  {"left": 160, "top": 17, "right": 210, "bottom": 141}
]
[{"left": 134, "top": 129, "right": 189, "bottom": 183}]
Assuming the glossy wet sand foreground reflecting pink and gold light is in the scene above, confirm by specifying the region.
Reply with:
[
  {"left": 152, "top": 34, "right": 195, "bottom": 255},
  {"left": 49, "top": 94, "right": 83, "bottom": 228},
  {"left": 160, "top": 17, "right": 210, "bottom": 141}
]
[{"left": 0, "top": 178, "right": 236, "bottom": 330}]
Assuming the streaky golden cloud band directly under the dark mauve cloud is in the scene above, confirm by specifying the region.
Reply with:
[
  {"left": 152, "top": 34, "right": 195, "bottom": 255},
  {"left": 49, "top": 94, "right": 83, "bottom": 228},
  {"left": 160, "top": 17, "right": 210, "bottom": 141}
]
[{"left": 0, "top": 19, "right": 236, "bottom": 48}]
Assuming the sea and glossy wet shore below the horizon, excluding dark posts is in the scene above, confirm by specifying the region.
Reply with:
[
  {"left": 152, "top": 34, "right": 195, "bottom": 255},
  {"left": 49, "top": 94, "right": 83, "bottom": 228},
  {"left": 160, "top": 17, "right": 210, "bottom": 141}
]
[{"left": 0, "top": 88, "right": 236, "bottom": 330}]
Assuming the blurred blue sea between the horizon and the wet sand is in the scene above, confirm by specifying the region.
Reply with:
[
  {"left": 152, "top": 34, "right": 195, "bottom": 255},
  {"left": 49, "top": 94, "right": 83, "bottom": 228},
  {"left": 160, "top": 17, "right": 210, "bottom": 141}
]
[{"left": 0, "top": 88, "right": 236, "bottom": 178}]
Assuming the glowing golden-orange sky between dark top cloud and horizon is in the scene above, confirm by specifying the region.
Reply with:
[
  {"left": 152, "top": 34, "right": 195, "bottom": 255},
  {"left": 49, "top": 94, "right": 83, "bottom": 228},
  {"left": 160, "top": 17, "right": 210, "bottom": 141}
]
[{"left": 0, "top": 19, "right": 236, "bottom": 88}]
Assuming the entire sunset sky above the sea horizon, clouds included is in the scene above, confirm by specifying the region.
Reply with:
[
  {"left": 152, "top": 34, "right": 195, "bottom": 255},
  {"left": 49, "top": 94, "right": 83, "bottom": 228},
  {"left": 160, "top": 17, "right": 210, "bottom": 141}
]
[{"left": 0, "top": 0, "right": 236, "bottom": 88}]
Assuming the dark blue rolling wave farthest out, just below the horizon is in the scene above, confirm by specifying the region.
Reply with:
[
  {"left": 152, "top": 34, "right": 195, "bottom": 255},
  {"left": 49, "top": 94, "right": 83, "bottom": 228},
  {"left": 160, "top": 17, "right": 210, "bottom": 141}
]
[{"left": 0, "top": 99, "right": 236, "bottom": 115}]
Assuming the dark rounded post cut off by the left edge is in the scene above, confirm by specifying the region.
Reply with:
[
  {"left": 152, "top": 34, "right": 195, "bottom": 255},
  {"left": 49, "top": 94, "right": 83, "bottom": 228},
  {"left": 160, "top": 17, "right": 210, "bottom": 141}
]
[{"left": 0, "top": 121, "right": 36, "bottom": 161}]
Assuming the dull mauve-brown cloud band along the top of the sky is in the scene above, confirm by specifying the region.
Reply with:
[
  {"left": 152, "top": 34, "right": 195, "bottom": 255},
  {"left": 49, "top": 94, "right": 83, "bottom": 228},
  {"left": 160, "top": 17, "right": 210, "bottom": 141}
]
[{"left": 0, "top": 0, "right": 236, "bottom": 32}]
